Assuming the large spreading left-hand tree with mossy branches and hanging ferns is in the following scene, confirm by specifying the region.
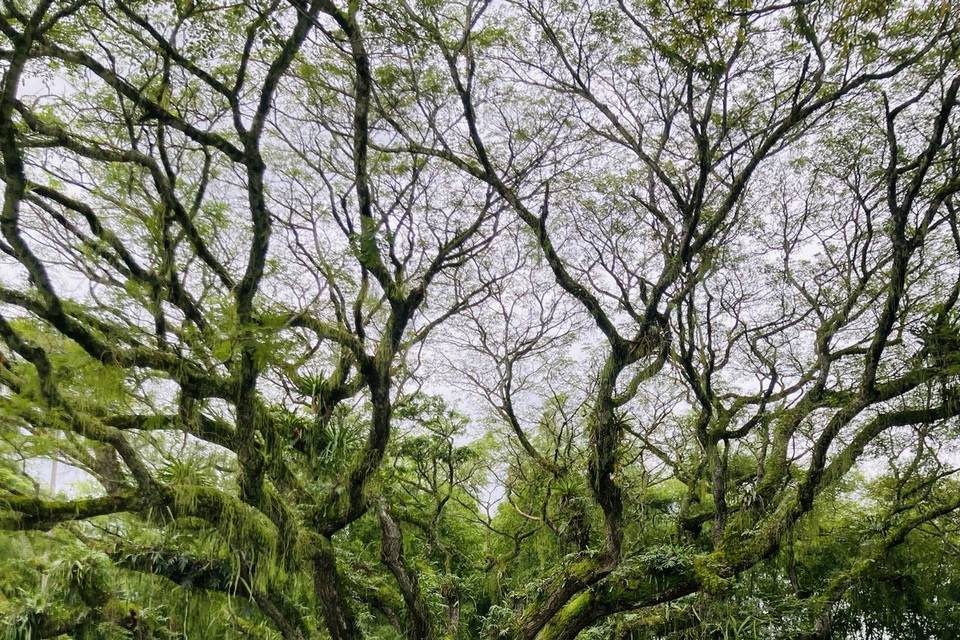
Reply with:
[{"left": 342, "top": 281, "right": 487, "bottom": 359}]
[{"left": 0, "top": 2, "right": 499, "bottom": 638}]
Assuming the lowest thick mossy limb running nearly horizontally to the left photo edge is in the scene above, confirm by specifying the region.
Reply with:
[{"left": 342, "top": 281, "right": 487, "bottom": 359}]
[{"left": 0, "top": 492, "right": 147, "bottom": 530}]
